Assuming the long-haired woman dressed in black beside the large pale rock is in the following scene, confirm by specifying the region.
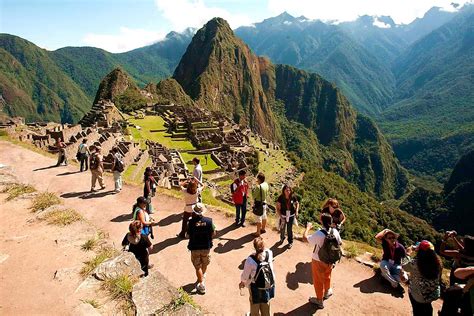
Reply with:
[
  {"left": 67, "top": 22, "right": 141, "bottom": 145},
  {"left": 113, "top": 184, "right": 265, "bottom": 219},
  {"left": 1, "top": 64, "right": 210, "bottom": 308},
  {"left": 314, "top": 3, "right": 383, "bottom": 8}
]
[{"left": 122, "top": 221, "right": 153, "bottom": 276}]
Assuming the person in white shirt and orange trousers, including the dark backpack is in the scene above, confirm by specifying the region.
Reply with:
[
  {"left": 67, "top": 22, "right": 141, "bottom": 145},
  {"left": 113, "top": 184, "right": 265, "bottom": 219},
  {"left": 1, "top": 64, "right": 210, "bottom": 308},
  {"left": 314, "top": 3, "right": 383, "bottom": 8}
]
[{"left": 303, "top": 214, "right": 342, "bottom": 309}]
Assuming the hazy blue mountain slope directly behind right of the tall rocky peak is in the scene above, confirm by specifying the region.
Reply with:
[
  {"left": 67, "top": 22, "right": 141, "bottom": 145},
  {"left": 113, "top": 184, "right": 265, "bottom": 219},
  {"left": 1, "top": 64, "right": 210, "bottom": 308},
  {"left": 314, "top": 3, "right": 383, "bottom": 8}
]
[{"left": 235, "top": 13, "right": 395, "bottom": 113}]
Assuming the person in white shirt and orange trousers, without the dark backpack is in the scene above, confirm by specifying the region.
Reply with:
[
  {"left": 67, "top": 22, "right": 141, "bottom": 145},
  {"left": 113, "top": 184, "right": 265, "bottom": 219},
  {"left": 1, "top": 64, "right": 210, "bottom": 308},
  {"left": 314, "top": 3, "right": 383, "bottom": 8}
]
[{"left": 303, "top": 214, "right": 342, "bottom": 309}]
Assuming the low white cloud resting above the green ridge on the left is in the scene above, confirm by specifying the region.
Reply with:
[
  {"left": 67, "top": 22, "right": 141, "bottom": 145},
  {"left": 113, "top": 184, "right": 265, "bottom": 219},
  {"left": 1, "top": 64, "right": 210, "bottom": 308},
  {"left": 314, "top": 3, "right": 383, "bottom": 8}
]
[{"left": 82, "top": 27, "right": 166, "bottom": 53}]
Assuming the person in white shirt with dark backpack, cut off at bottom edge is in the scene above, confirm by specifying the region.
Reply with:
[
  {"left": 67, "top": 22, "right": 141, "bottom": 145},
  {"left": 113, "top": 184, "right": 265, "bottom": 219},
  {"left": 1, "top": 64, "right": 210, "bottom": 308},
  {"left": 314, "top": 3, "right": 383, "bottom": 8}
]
[{"left": 239, "top": 237, "right": 275, "bottom": 316}]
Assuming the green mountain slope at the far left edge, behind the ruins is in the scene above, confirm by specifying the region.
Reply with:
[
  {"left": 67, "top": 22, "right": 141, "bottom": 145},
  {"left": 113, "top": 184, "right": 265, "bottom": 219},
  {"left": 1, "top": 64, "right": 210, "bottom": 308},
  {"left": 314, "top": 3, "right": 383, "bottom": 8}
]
[{"left": 0, "top": 34, "right": 90, "bottom": 123}]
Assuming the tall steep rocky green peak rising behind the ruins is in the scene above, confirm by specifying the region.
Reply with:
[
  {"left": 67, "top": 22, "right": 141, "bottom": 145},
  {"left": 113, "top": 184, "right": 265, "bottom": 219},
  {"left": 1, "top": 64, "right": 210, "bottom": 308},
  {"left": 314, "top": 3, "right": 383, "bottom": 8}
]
[{"left": 174, "top": 18, "right": 408, "bottom": 199}]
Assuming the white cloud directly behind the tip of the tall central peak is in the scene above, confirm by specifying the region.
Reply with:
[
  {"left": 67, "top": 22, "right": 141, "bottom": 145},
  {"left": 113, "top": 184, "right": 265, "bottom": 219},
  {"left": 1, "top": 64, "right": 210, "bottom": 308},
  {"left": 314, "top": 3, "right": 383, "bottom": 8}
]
[{"left": 155, "top": 0, "right": 252, "bottom": 32}]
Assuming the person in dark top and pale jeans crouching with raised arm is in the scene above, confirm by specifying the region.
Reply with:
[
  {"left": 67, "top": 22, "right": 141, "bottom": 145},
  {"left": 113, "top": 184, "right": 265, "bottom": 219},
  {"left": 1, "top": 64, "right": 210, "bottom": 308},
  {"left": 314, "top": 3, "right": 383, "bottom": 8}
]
[{"left": 375, "top": 229, "right": 407, "bottom": 294}]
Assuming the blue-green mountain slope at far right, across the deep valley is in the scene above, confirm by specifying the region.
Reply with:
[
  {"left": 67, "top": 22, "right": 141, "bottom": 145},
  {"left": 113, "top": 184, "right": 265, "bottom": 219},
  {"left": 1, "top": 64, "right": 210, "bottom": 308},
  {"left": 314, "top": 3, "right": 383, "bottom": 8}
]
[{"left": 380, "top": 6, "right": 474, "bottom": 179}]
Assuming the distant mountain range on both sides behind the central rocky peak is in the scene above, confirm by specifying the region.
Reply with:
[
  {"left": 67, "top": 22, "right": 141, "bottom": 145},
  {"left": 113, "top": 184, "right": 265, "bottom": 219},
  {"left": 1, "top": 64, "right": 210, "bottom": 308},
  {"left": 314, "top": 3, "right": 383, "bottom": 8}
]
[{"left": 0, "top": 5, "right": 474, "bottom": 181}]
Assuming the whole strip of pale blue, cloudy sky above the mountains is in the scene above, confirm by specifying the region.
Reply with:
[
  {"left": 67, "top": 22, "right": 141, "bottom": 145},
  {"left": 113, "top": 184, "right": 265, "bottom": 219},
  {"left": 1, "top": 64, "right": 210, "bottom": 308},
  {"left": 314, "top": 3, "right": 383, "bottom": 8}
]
[{"left": 0, "top": 0, "right": 473, "bottom": 53}]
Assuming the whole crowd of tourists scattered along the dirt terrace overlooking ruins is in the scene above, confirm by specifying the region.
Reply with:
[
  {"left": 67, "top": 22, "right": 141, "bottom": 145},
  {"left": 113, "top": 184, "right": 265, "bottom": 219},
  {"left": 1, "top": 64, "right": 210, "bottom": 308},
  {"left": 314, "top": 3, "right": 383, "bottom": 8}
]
[{"left": 53, "top": 146, "right": 474, "bottom": 316}]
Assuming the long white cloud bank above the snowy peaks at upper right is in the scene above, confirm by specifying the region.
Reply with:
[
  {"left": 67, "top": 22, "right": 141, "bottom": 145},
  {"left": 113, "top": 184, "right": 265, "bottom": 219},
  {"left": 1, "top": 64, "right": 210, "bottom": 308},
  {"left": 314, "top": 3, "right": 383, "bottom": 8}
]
[{"left": 268, "top": 0, "right": 472, "bottom": 24}]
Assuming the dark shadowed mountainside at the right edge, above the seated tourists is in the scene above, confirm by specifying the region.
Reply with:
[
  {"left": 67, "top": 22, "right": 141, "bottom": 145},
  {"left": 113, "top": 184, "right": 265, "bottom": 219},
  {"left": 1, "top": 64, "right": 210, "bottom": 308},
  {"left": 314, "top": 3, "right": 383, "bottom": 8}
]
[{"left": 400, "top": 150, "right": 474, "bottom": 234}]
